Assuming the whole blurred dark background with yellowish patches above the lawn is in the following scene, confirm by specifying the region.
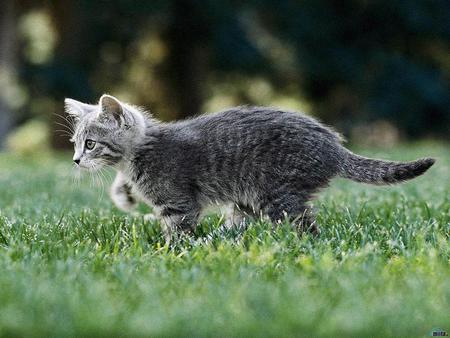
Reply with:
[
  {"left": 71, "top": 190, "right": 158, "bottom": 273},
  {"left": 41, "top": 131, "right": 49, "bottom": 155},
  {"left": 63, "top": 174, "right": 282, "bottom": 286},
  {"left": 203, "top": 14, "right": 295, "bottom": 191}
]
[{"left": 0, "top": 0, "right": 450, "bottom": 152}]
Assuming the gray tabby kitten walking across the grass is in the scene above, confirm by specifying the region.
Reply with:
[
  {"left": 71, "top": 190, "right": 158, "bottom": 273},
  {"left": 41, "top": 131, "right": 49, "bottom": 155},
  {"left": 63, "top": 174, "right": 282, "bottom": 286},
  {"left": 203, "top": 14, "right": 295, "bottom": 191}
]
[{"left": 65, "top": 95, "right": 434, "bottom": 237}]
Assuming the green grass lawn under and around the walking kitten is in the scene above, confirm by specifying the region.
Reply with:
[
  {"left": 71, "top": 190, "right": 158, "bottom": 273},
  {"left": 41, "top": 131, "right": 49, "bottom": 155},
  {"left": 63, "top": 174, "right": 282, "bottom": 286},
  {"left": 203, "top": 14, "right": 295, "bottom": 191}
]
[{"left": 0, "top": 144, "right": 450, "bottom": 337}]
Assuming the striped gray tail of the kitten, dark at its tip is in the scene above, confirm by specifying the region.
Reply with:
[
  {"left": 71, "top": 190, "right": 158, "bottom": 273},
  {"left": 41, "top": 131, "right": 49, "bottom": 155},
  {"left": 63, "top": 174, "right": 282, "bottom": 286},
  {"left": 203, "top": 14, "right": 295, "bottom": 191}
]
[{"left": 341, "top": 152, "right": 435, "bottom": 184}]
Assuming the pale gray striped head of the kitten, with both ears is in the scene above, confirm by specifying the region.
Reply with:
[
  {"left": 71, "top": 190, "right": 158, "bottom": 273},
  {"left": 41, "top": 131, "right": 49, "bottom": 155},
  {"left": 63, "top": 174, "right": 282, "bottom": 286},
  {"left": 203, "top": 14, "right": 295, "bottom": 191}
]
[{"left": 65, "top": 95, "right": 145, "bottom": 169}]
